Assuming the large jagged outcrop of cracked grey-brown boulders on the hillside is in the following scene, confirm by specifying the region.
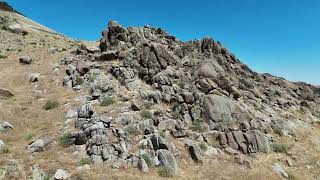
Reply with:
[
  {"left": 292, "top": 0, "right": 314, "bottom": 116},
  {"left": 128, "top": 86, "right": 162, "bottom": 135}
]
[{"left": 62, "top": 21, "right": 320, "bottom": 172}]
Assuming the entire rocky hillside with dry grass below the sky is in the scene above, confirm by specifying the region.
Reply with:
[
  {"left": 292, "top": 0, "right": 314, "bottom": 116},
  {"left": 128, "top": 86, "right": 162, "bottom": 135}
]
[{"left": 0, "top": 9, "right": 320, "bottom": 179}]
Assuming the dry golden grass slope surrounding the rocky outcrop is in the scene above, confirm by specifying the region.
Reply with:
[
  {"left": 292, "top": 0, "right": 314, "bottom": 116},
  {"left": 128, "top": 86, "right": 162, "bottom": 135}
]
[{"left": 0, "top": 12, "right": 320, "bottom": 180}]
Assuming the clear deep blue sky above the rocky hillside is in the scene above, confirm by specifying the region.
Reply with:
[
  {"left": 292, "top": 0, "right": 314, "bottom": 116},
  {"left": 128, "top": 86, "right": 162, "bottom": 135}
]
[{"left": 7, "top": 0, "right": 320, "bottom": 84}]
